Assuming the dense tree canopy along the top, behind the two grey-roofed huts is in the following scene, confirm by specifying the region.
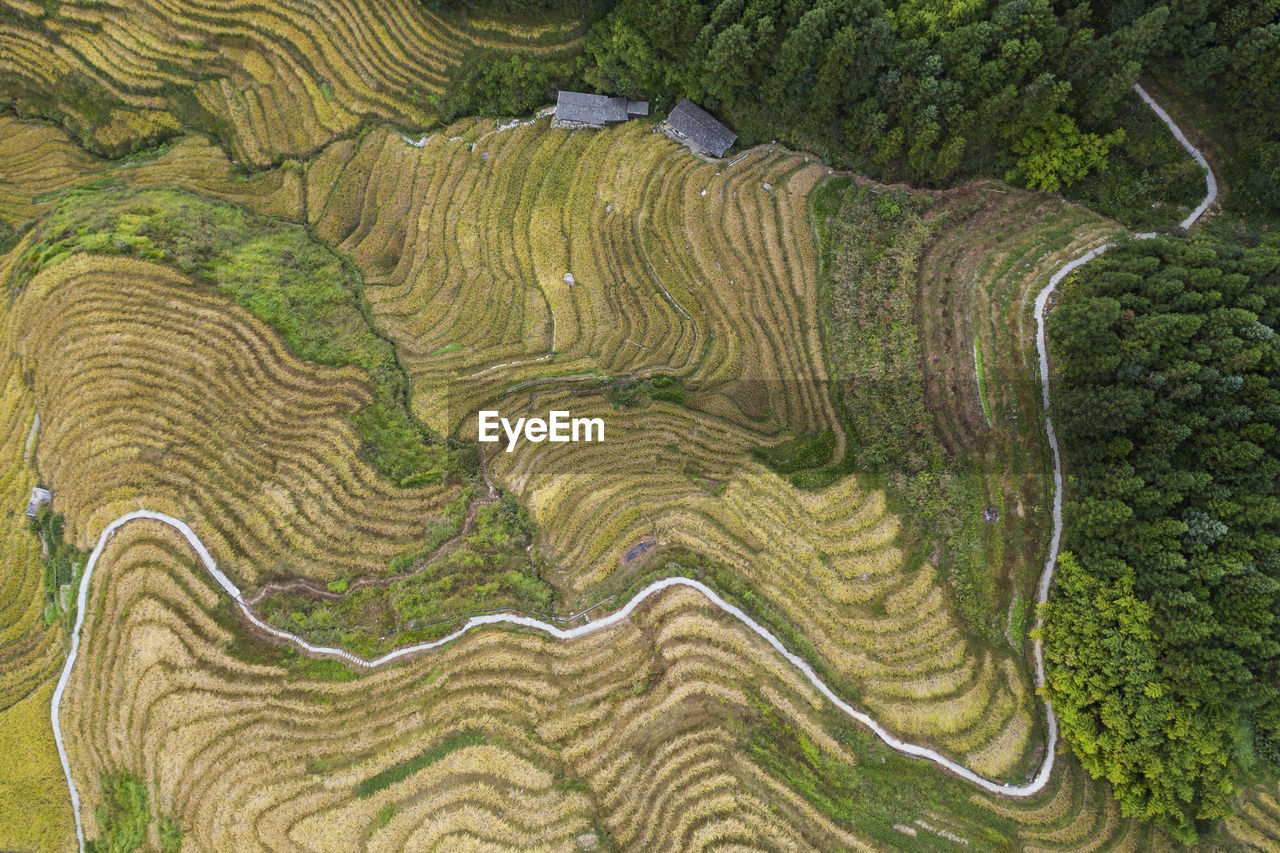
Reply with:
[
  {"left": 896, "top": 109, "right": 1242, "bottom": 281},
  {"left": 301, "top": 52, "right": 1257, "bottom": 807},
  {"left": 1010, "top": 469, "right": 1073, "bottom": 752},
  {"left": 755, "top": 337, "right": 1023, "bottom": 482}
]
[{"left": 586, "top": 0, "right": 1167, "bottom": 187}]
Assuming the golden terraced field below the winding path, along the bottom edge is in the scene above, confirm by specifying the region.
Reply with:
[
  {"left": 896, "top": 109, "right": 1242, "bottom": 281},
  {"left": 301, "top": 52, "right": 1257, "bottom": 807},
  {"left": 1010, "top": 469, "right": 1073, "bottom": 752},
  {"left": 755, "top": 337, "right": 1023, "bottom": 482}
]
[{"left": 49, "top": 507, "right": 1187, "bottom": 850}]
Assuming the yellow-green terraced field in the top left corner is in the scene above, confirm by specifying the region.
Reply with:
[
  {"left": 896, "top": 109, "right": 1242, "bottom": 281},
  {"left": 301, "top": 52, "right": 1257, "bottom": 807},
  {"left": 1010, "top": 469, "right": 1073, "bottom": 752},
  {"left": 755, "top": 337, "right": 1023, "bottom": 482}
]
[{"left": 0, "top": 0, "right": 581, "bottom": 167}]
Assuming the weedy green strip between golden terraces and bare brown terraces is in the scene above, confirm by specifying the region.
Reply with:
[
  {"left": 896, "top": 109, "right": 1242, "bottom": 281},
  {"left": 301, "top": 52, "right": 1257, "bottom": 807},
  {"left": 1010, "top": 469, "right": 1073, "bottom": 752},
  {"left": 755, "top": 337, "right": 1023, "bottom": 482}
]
[{"left": 812, "top": 179, "right": 1005, "bottom": 642}]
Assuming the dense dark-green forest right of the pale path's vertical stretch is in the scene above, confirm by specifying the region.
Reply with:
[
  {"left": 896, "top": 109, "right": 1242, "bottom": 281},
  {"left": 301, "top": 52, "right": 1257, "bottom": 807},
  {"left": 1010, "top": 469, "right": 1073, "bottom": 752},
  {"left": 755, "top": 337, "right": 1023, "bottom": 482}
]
[{"left": 1043, "top": 236, "right": 1280, "bottom": 840}]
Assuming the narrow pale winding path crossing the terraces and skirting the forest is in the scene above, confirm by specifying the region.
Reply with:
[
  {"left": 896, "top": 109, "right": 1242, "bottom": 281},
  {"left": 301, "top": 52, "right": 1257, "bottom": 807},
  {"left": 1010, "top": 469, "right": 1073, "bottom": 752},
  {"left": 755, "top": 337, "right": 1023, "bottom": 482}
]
[{"left": 50, "top": 83, "right": 1217, "bottom": 853}]
